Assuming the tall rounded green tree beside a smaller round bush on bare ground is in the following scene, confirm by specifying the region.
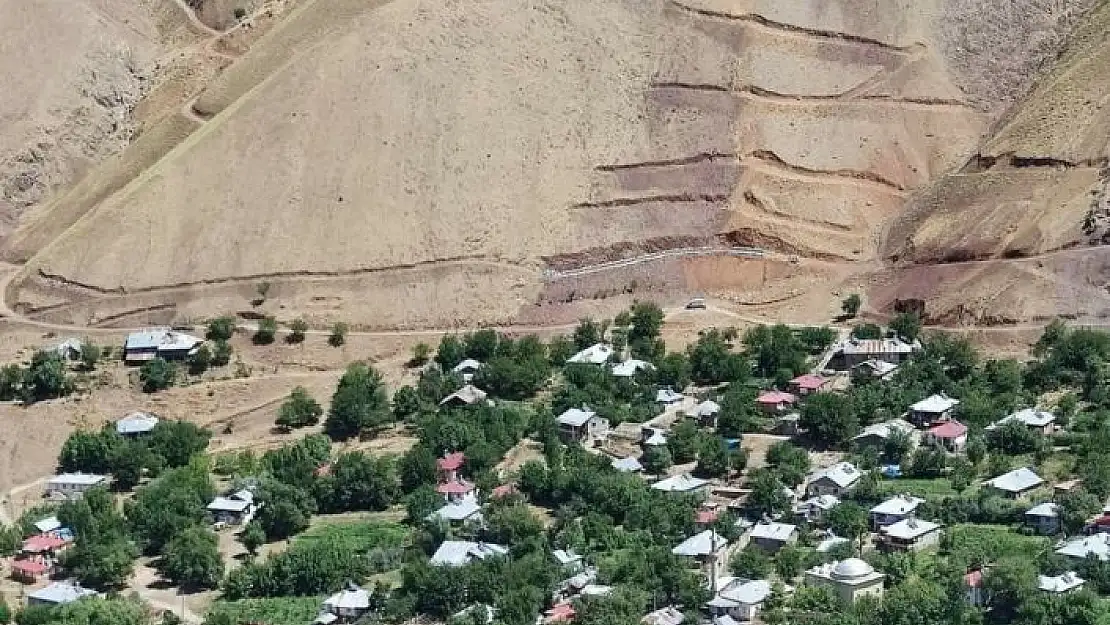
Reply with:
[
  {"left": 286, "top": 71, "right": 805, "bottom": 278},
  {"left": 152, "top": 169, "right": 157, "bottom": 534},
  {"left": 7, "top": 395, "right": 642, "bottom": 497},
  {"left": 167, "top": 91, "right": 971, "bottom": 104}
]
[{"left": 324, "top": 363, "right": 392, "bottom": 441}]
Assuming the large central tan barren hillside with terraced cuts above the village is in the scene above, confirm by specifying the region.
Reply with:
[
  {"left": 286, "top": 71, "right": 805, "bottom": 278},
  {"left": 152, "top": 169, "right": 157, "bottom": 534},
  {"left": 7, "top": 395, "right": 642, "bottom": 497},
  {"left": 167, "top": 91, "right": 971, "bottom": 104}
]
[{"left": 7, "top": 0, "right": 1091, "bottom": 327}]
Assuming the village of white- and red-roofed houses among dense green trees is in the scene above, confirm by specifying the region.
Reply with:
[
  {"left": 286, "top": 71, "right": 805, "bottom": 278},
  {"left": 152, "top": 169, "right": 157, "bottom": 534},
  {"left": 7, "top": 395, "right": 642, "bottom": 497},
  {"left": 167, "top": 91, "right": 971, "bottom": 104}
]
[{"left": 4, "top": 301, "right": 1110, "bottom": 625}]
